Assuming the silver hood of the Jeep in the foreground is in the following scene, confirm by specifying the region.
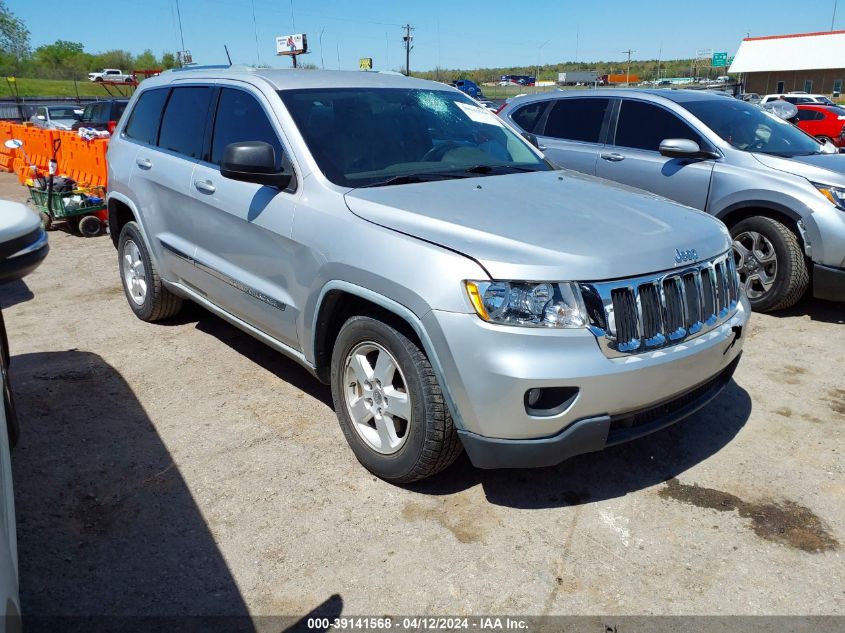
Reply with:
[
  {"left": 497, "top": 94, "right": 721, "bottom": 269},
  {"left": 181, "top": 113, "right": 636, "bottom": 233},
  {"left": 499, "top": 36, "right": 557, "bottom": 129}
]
[{"left": 346, "top": 171, "right": 730, "bottom": 281}]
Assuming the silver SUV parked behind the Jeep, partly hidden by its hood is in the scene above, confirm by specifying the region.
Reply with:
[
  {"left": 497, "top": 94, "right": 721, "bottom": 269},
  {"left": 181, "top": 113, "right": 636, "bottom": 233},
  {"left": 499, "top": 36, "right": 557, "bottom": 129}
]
[{"left": 500, "top": 90, "right": 845, "bottom": 311}]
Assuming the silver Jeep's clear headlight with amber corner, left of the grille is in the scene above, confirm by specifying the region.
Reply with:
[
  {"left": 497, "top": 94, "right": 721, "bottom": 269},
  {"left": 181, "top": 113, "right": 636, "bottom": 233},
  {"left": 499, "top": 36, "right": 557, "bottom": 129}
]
[{"left": 465, "top": 281, "right": 587, "bottom": 328}]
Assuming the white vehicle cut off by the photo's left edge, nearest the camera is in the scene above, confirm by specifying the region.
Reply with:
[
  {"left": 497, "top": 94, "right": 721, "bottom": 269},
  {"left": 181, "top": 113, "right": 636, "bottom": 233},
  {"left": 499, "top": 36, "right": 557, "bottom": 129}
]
[{"left": 0, "top": 201, "right": 49, "bottom": 631}]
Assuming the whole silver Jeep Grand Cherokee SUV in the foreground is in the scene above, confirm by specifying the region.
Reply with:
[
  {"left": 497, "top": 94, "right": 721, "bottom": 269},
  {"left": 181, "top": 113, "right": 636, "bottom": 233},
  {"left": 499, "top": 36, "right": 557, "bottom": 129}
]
[{"left": 108, "top": 68, "right": 750, "bottom": 482}]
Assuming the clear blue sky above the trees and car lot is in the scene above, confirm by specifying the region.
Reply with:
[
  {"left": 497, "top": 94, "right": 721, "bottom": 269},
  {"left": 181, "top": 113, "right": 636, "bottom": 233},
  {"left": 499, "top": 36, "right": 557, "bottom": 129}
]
[{"left": 7, "top": 0, "right": 845, "bottom": 70}]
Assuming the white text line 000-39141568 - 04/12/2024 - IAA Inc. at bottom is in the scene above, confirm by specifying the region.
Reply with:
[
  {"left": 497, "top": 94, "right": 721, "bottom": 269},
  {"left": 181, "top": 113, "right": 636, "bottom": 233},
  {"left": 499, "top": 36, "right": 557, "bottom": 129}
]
[{"left": 306, "top": 616, "right": 528, "bottom": 631}]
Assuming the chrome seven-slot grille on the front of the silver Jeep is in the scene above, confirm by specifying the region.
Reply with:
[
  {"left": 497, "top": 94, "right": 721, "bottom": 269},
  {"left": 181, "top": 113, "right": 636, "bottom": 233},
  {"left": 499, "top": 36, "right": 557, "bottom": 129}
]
[{"left": 580, "top": 252, "right": 739, "bottom": 357}]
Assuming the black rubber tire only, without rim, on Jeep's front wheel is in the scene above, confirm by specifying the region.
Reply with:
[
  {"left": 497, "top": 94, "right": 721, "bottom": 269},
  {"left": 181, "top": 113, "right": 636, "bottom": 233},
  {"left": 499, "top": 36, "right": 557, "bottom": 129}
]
[{"left": 331, "top": 316, "right": 463, "bottom": 483}]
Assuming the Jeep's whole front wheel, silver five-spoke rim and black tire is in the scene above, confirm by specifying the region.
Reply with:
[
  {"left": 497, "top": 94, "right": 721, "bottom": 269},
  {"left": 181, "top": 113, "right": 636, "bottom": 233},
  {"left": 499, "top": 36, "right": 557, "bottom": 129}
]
[{"left": 331, "top": 316, "right": 462, "bottom": 483}]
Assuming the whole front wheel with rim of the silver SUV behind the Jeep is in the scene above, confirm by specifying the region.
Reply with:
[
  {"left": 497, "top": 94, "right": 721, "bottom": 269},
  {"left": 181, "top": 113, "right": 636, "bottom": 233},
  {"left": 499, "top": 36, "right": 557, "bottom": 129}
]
[{"left": 731, "top": 216, "right": 810, "bottom": 312}]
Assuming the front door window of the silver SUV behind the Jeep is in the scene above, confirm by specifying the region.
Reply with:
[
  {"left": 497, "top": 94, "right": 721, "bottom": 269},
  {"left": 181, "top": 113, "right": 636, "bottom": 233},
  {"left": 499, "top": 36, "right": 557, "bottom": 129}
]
[{"left": 616, "top": 99, "right": 704, "bottom": 152}]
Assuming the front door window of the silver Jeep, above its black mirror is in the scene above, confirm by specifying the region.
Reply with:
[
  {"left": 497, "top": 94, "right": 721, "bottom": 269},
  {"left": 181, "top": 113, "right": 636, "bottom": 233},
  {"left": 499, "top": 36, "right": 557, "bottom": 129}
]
[{"left": 211, "top": 88, "right": 284, "bottom": 169}]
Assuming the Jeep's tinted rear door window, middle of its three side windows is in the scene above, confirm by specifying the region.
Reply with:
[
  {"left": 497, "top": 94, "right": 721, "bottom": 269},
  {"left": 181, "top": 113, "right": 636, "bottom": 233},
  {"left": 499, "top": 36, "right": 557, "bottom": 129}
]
[{"left": 158, "top": 86, "right": 211, "bottom": 158}]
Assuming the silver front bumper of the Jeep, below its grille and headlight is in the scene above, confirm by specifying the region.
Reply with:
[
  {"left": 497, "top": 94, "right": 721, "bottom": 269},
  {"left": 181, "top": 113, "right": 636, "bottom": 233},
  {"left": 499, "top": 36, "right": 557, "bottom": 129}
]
[{"left": 423, "top": 298, "right": 751, "bottom": 467}]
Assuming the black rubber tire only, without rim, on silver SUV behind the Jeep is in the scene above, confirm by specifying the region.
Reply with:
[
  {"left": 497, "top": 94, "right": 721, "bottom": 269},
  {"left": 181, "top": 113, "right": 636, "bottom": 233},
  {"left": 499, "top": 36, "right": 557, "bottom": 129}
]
[{"left": 731, "top": 216, "right": 810, "bottom": 312}]
